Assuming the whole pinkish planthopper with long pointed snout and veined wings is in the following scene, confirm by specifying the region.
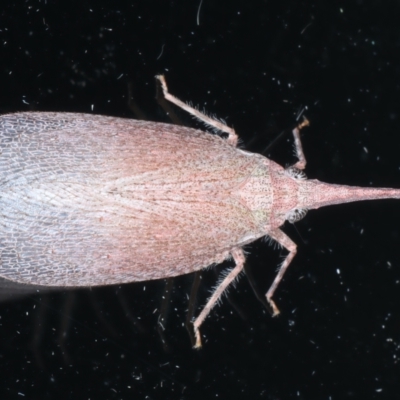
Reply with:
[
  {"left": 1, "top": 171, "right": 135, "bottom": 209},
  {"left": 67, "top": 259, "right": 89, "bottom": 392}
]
[{"left": 0, "top": 76, "right": 400, "bottom": 347}]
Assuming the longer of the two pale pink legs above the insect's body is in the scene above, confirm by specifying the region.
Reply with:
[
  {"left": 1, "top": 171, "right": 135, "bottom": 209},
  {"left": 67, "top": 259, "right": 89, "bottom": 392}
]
[{"left": 156, "top": 75, "right": 238, "bottom": 147}]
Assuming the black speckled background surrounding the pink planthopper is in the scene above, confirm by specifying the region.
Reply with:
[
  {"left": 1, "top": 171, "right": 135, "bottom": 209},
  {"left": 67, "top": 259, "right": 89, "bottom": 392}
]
[{"left": 0, "top": 0, "right": 400, "bottom": 400}]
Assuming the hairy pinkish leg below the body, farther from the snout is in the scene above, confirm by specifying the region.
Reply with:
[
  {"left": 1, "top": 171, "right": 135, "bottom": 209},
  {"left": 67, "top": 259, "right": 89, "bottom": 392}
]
[{"left": 193, "top": 248, "right": 246, "bottom": 349}]
